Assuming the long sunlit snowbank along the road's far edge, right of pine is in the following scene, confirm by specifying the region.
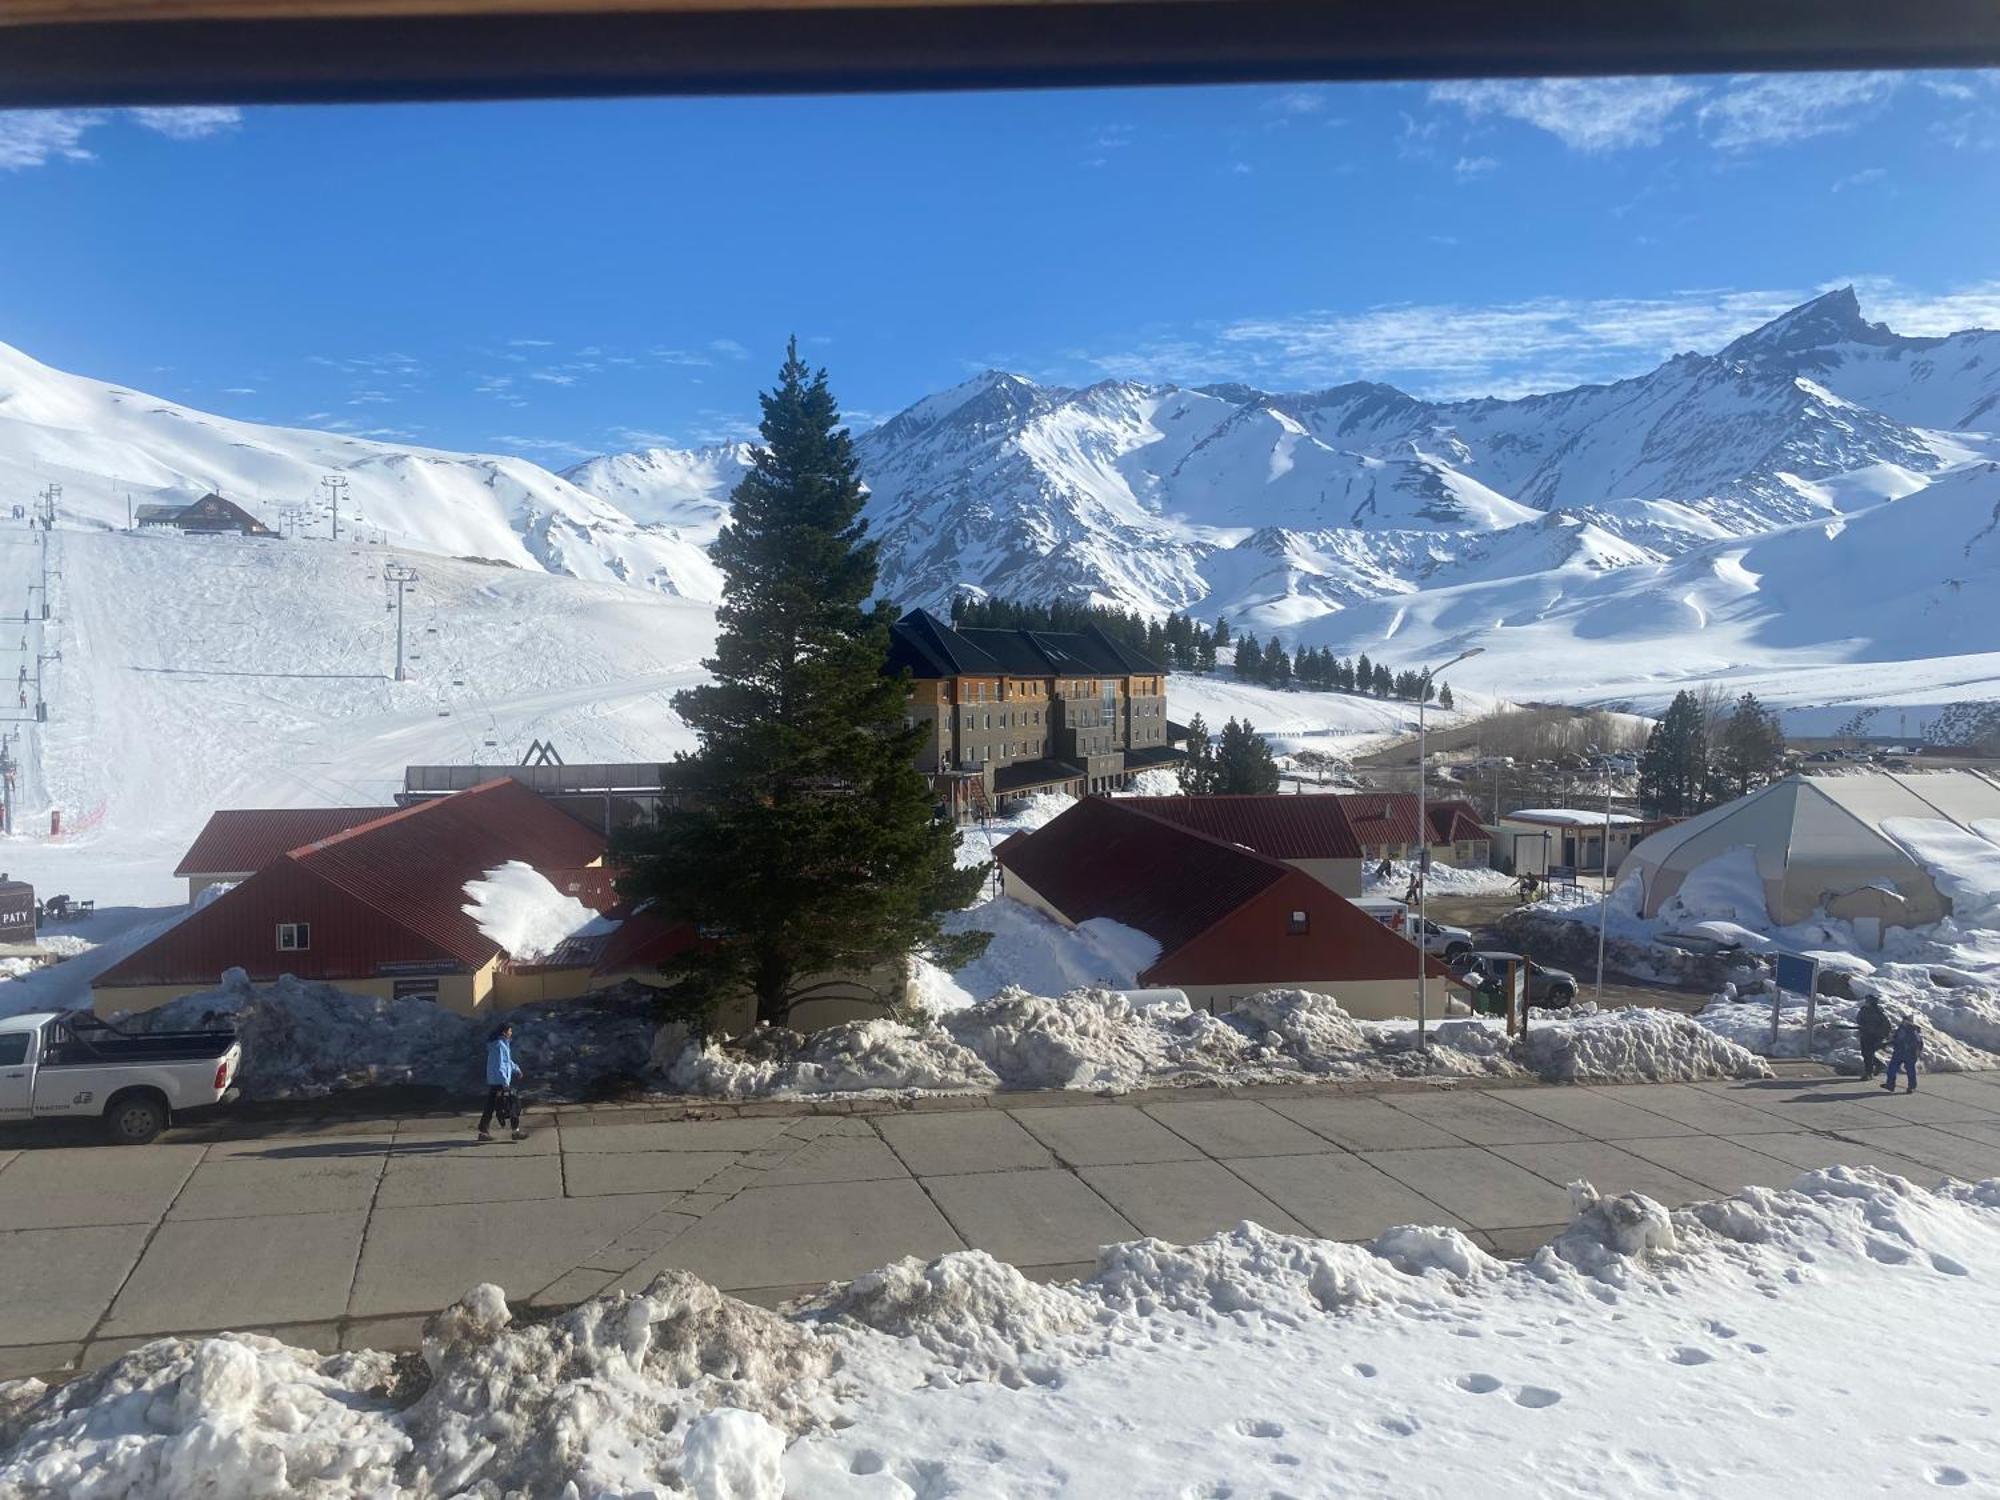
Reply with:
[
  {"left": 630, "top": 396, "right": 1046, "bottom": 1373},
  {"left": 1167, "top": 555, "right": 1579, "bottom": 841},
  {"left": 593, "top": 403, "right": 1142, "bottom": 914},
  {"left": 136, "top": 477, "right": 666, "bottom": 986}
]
[{"left": 658, "top": 988, "right": 1768, "bottom": 1098}]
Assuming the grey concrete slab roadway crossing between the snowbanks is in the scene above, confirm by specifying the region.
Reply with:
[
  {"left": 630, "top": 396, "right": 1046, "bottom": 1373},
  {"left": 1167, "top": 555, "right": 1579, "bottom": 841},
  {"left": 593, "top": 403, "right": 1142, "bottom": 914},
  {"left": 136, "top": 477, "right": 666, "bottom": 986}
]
[{"left": 0, "top": 1074, "right": 2000, "bottom": 1376}]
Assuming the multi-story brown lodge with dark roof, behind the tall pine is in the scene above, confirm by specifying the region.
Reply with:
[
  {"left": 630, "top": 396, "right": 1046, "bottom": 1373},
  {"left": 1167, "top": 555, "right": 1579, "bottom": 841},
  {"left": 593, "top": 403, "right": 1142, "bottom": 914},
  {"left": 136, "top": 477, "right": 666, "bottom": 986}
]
[{"left": 888, "top": 610, "right": 1180, "bottom": 818}]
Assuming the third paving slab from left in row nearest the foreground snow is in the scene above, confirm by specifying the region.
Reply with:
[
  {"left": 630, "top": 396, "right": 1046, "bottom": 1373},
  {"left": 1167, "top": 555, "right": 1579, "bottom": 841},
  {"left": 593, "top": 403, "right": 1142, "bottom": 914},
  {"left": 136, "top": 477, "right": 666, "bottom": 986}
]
[{"left": 346, "top": 1192, "right": 672, "bottom": 1318}]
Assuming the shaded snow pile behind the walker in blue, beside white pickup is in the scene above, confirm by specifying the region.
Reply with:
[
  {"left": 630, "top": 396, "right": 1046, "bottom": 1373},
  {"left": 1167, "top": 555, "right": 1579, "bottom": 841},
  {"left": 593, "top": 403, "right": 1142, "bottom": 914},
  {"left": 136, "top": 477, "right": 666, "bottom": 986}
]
[{"left": 135, "top": 968, "right": 656, "bottom": 1098}]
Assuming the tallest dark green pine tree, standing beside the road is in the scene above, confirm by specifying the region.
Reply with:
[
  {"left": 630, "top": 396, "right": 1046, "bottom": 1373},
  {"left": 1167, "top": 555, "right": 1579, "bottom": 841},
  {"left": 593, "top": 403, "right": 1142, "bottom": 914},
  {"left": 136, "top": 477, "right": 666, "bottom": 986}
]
[{"left": 618, "top": 340, "right": 988, "bottom": 1026}]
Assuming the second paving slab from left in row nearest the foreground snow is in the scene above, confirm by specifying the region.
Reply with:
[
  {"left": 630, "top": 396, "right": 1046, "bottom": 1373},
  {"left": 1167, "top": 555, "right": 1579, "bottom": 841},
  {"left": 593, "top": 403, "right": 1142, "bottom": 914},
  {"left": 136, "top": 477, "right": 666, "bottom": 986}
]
[{"left": 98, "top": 1212, "right": 368, "bottom": 1336}]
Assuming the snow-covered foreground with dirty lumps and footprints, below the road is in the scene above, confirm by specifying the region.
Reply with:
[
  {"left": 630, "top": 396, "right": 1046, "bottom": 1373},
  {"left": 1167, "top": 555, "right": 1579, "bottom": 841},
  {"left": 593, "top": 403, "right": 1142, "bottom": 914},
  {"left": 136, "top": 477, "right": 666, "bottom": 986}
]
[{"left": 0, "top": 1168, "right": 2000, "bottom": 1500}]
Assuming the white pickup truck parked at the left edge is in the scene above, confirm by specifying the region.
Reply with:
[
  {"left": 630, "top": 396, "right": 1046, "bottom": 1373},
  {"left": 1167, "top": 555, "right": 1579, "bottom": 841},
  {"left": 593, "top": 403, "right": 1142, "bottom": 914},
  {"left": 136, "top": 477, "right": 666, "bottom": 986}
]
[{"left": 0, "top": 1010, "right": 244, "bottom": 1146}]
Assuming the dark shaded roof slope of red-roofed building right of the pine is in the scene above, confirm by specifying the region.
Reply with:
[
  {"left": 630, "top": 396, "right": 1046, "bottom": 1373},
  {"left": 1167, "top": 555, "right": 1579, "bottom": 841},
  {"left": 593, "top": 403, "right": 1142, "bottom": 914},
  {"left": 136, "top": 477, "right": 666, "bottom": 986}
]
[{"left": 994, "top": 796, "right": 1290, "bottom": 958}]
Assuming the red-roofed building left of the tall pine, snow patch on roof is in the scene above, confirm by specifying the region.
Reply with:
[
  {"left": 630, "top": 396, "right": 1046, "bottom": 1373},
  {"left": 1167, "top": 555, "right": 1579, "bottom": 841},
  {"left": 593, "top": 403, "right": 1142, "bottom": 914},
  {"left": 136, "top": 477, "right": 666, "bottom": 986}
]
[{"left": 92, "top": 780, "right": 610, "bottom": 1014}]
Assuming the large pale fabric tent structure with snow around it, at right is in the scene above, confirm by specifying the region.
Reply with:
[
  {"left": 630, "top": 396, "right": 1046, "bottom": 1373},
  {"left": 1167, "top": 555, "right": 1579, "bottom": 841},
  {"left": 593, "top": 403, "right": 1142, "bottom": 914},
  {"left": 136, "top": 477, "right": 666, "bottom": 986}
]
[{"left": 1626, "top": 770, "right": 2000, "bottom": 926}]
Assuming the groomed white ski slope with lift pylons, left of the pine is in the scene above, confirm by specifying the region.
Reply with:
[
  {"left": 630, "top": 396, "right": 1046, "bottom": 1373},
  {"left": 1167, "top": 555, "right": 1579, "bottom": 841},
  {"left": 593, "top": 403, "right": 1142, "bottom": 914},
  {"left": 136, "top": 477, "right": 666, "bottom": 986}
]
[{"left": 0, "top": 528, "right": 714, "bottom": 904}]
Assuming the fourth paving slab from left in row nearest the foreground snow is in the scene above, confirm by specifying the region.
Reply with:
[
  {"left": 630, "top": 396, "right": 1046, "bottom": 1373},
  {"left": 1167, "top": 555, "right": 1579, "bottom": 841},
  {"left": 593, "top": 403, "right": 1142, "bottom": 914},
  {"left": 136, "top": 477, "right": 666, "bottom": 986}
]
[{"left": 624, "top": 1176, "right": 980, "bottom": 1290}]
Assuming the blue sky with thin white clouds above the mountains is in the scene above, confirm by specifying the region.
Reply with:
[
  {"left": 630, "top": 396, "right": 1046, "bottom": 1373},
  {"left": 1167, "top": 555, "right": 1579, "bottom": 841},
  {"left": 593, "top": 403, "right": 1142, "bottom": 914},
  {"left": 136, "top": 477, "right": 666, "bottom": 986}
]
[{"left": 0, "top": 74, "right": 2000, "bottom": 464}]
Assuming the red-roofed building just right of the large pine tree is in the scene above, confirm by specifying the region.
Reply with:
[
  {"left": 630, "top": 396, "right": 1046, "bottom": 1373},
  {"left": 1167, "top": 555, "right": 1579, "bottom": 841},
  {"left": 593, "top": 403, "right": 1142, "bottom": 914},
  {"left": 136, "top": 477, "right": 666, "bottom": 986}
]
[{"left": 996, "top": 796, "right": 1456, "bottom": 1018}]
